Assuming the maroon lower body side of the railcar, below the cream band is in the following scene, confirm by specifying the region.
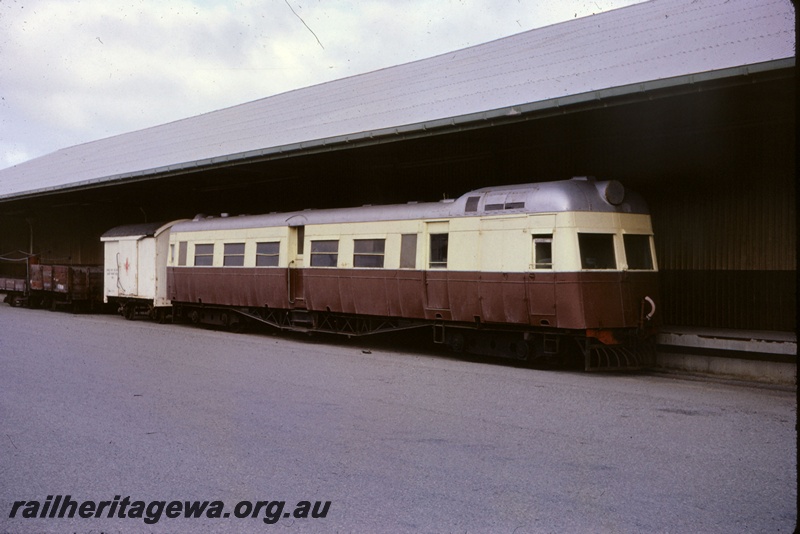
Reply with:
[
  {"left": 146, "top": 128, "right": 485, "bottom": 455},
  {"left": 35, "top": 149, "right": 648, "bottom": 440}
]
[{"left": 167, "top": 267, "right": 658, "bottom": 329}]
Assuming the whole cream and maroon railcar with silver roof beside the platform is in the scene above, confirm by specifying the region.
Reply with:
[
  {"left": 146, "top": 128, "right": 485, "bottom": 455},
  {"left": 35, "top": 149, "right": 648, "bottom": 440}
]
[{"left": 167, "top": 178, "right": 658, "bottom": 368}]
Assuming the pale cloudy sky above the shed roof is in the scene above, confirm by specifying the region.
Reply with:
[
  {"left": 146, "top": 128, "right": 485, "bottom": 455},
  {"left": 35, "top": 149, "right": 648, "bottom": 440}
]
[{"left": 0, "top": 0, "right": 642, "bottom": 169}]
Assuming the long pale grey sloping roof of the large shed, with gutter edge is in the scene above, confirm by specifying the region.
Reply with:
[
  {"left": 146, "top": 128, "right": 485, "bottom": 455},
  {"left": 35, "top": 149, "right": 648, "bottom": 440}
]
[{"left": 0, "top": 0, "right": 795, "bottom": 199}]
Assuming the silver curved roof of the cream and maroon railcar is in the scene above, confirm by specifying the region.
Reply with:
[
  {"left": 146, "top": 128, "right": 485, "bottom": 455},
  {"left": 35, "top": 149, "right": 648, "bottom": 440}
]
[{"left": 172, "top": 178, "right": 648, "bottom": 232}]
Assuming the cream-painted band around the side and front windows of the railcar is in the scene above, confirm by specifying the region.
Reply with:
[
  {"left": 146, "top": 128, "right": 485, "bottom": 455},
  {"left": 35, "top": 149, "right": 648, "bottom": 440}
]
[{"left": 169, "top": 213, "right": 655, "bottom": 272}]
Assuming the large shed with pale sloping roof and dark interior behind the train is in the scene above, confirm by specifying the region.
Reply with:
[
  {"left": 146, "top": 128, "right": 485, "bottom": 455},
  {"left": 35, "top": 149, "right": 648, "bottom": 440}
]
[{"left": 0, "top": 0, "right": 796, "bottom": 368}]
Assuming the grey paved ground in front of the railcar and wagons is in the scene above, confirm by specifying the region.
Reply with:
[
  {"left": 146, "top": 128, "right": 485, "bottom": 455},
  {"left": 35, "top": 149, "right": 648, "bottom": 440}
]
[{"left": 0, "top": 305, "right": 797, "bottom": 534}]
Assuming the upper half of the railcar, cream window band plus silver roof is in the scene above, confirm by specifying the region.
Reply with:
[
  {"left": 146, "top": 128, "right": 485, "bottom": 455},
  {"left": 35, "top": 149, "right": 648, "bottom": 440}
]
[{"left": 168, "top": 179, "right": 656, "bottom": 272}]
